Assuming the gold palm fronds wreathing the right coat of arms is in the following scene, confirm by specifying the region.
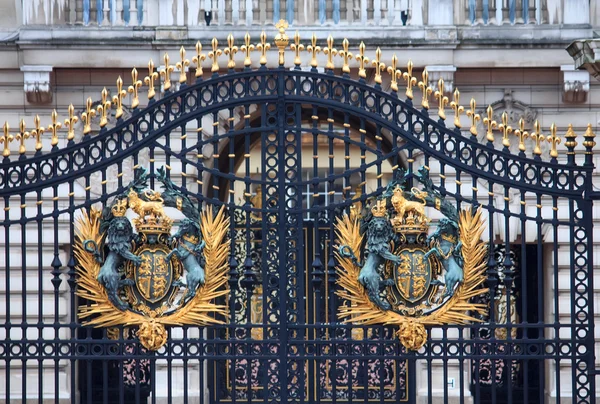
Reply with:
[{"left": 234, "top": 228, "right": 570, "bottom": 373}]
[{"left": 336, "top": 208, "right": 488, "bottom": 349}]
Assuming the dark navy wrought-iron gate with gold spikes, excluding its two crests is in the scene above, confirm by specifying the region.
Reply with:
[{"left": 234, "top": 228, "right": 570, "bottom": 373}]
[{"left": 0, "top": 26, "right": 596, "bottom": 403}]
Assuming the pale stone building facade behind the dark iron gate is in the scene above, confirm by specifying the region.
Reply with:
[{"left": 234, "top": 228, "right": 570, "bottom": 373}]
[{"left": 0, "top": 0, "right": 600, "bottom": 403}]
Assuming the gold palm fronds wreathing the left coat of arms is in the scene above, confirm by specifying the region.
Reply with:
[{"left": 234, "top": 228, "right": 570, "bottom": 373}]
[{"left": 74, "top": 206, "right": 230, "bottom": 350}]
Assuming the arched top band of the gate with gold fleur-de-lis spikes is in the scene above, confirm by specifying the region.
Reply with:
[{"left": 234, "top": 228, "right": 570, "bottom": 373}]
[{"left": 0, "top": 22, "right": 595, "bottom": 197}]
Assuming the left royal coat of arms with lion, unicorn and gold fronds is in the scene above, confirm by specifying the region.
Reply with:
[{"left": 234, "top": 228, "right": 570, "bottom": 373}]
[{"left": 74, "top": 168, "right": 230, "bottom": 350}]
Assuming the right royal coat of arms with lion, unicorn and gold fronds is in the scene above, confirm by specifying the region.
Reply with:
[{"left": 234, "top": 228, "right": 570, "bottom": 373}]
[{"left": 336, "top": 168, "right": 488, "bottom": 350}]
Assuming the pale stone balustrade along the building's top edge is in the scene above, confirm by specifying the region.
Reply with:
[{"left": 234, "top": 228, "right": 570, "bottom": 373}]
[{"left": 22, "top": 0, "right": 590, "bottom": 27}]
